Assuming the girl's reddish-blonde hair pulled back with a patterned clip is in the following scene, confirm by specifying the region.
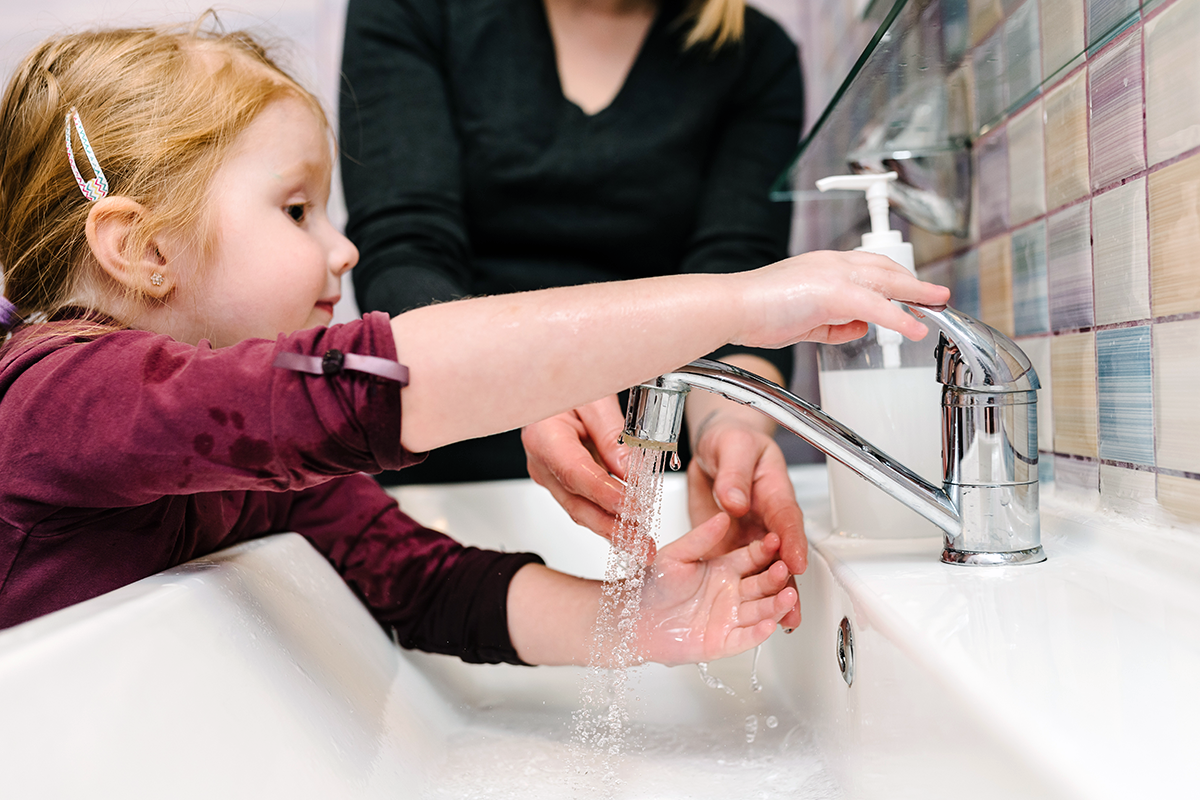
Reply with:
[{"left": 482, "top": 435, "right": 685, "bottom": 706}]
[{"left": 0, "top": 18, "right": 329, "bottom": 335}]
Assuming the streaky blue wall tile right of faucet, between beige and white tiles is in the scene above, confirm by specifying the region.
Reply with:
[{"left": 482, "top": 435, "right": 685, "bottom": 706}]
[{"left": 1096, "top": 325, "right": 1154, "bottom": 465}]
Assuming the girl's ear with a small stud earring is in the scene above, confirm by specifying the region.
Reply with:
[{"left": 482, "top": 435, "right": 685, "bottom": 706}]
[{"left": 86, "top": 196, "right": 178, "bottom": 300}]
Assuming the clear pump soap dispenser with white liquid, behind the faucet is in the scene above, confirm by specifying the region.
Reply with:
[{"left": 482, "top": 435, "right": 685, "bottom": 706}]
[{"left": 817, "top": 173, "right": 942, "bottom": 539}]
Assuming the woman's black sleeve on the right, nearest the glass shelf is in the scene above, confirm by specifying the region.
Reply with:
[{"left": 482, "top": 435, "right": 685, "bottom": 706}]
[{"left": 680, "top": 17, "right": 804, "bottom": 379}]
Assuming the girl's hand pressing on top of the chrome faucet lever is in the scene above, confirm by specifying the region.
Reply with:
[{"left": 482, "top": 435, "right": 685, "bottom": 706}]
[{"left": 733, "top": 251, "right": 950, "bottom": 348}]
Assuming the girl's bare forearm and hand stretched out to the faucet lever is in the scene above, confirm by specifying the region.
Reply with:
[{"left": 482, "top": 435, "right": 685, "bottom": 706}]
[{"left": 392, "top": 252, "right": 949, "bottom": 451}]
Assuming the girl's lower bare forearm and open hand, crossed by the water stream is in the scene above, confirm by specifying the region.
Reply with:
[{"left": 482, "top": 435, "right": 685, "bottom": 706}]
[{"left": 508, "top": 515, "right": 797, "bottom": 666}]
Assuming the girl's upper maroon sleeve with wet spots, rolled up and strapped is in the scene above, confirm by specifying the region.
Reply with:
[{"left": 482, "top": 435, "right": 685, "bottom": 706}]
[{"left": 5, "top": 313, "right": 416, "bottom": 509}]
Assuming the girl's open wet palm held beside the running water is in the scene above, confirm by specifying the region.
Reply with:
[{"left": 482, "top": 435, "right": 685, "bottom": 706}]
[{"left": 637, "top": 513, "right": 799, "bottom": 664}]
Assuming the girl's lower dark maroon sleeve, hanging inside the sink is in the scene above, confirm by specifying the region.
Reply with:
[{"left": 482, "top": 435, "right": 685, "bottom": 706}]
[{"left": 288, "top": 475, "right": 542, "bottom": 664}]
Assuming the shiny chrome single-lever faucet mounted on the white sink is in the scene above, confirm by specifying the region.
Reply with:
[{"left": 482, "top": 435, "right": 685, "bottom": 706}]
[{"left": 622, "top": 306, "right": 1045, "bottom": 566}]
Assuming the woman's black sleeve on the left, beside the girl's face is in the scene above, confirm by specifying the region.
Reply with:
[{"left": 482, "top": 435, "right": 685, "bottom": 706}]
[{"left": 338, "top": 0, "right": 469, "bottom": 314}]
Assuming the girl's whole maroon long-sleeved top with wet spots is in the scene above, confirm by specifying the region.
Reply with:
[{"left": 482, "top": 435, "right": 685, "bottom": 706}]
[{"left": 0, "top": 313, "right": 540, "bottom": 663}]
